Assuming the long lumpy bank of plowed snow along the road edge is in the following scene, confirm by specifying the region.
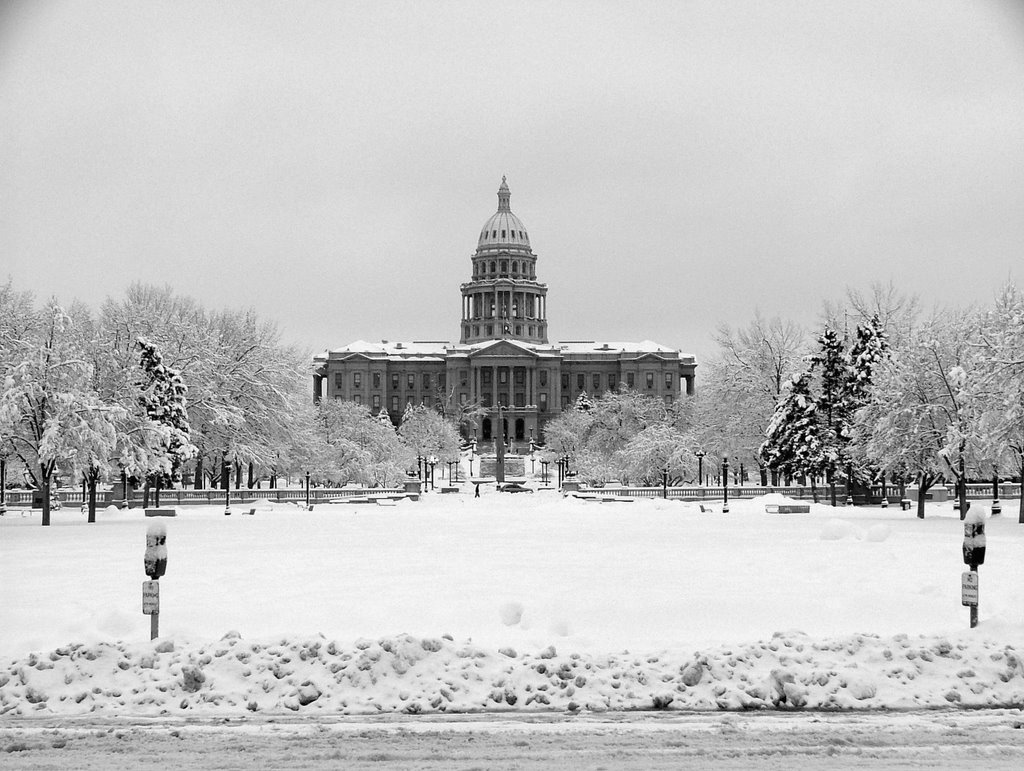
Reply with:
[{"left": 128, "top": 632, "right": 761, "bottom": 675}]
[{"left": 0, "top": 632, "right": 1024, "bottom": 716}]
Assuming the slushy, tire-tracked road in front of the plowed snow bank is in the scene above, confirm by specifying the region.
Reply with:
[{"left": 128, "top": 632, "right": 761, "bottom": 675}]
[{"left": 0, "top": 710, "right": 1024, "bottom": 771}]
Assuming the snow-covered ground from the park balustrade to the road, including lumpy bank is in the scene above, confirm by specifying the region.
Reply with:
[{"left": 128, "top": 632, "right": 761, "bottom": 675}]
[{"left": 0, "top": 490, "right": 1024, "bottom": 715}]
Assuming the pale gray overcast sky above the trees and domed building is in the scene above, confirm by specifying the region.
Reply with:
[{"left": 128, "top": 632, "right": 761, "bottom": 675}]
[{"left": 0, "top": 0, "right": 1024, "bottom": 358}]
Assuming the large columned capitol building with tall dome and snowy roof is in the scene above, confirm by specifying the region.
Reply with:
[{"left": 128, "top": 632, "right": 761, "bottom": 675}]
[{"left": 313, "top": 177, "right": 696, "bottom": 442}]
